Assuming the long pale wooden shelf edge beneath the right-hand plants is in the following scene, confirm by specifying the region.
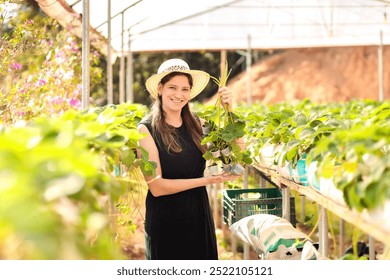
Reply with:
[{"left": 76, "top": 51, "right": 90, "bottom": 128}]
[{"left": 252, "top": 165, "right": 390, "bottom": 246}]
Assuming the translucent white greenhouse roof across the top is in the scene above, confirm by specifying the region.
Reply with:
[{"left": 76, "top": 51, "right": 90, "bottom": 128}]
[{"left": 55, "top": 0, "right": 390, "bottom": 52}]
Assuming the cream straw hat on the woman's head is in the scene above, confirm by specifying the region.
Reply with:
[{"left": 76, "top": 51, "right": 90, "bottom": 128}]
[{"left": 146, "top": 58, "right": 210, "bottom": 99}]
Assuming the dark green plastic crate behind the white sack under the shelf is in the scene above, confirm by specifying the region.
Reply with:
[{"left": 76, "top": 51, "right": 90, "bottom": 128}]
[{"left": 223, "top": 188, "right": 296, "bottom": 227}]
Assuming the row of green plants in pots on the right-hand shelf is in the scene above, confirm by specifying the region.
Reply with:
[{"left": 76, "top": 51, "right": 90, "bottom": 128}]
[{"left": 233, "top": 100, "right": 390, "bottom": 220}]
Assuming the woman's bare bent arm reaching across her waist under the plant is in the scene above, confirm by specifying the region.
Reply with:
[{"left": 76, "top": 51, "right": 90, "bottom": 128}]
[{"left": 138, "top": 124, "right": 240, "bottom": 196}]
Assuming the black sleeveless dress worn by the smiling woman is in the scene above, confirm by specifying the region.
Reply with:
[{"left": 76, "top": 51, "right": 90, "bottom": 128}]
[{"left": 142, "top": 122, "right": 218, "bottom": 260}]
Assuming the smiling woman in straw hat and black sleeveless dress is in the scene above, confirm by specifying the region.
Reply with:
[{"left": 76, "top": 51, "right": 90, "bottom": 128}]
[{"left": 138, "top": 59, "right": 239, "bottom": 260}]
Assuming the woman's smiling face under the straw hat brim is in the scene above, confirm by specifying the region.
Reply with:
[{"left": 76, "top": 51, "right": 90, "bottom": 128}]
[{"left": 159, "top": 75, "right": 191, "bottom": 112}]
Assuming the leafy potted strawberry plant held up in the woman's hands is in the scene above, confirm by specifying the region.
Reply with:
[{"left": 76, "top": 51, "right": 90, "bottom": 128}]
[{"left": 199, "top": 62, "right": 252, "bottom": 175}]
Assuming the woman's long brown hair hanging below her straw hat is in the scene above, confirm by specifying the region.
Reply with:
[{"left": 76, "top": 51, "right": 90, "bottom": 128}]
[{"left": 149, "top": 72, "right": 205, "bottom": 153}]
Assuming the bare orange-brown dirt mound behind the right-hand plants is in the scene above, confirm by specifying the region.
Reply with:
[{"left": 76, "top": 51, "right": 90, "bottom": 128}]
[{"left": 228, "top": 46, "right": 390, "bottom": 103}]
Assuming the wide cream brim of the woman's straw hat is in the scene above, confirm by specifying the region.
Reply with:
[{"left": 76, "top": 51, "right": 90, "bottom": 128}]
[{"left": 145, "top": 70, "right": 210, "bottom": 99}]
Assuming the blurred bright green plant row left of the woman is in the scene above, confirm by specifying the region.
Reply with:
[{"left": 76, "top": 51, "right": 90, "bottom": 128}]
[{"left": 0, "top": 104, "right": 155, "bottom": 259}]
